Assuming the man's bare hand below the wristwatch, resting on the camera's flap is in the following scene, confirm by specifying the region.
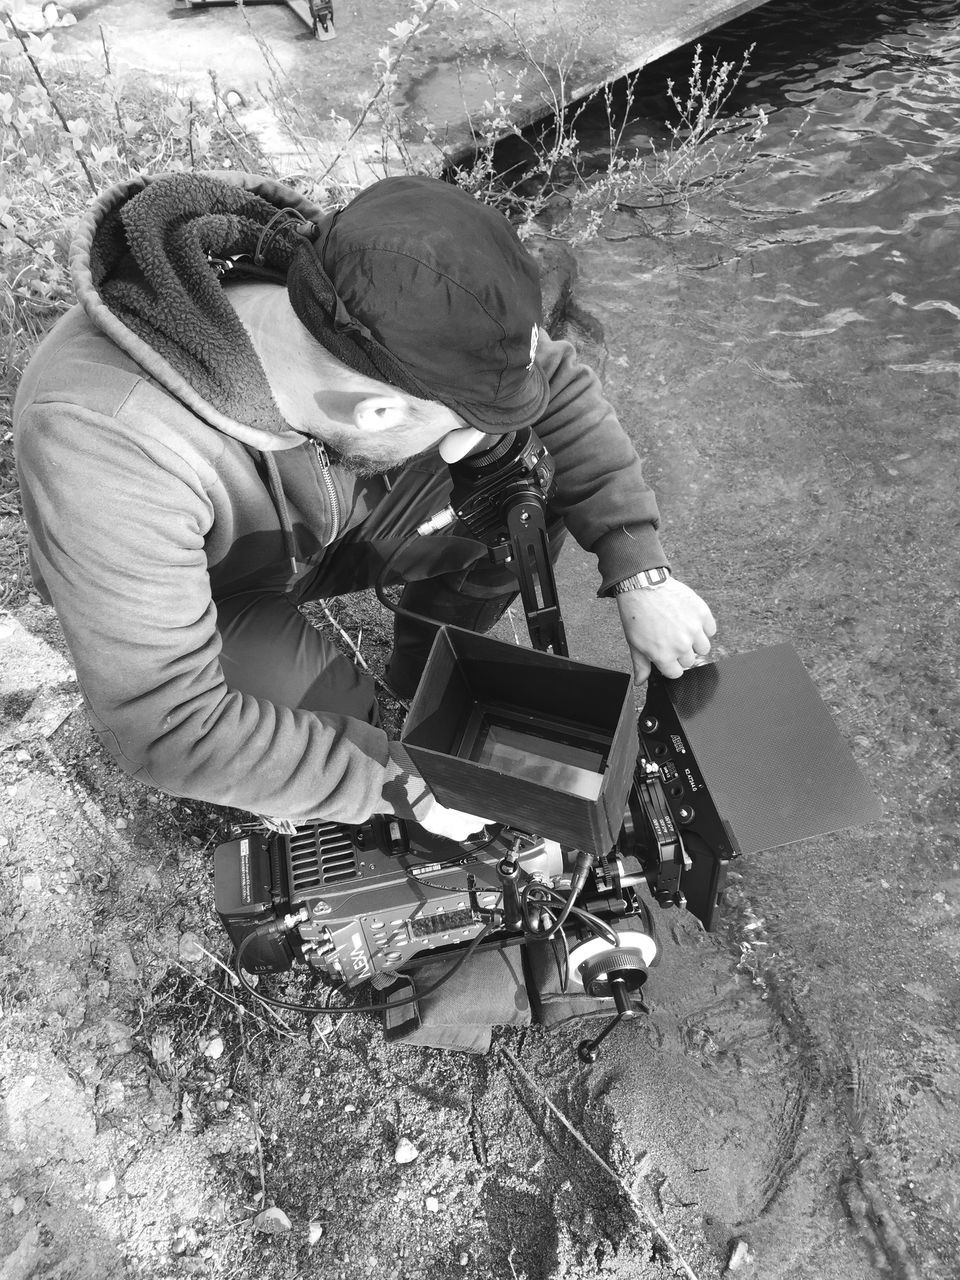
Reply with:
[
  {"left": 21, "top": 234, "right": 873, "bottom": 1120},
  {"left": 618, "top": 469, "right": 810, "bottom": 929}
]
[{"left": 616, "top": 577, "right": 717, "bottom": 684}]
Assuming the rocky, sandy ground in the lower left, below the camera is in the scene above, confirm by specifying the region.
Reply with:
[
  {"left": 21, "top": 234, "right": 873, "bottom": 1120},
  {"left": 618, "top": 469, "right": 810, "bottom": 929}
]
[{"left": 0, "top": 602, "right": 746, "bottom": 1280}]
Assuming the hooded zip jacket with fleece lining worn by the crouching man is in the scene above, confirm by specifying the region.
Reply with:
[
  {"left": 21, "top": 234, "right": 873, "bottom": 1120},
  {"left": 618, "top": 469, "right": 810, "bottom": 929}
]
[{"left": 14, "top": 174, "right": 666, "bottom": 823}]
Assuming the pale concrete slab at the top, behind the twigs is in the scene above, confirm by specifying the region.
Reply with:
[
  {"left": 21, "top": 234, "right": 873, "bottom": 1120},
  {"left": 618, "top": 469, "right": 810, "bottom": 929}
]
[{"left": 58, "top": 0, "right": 763, "bottom": 168}]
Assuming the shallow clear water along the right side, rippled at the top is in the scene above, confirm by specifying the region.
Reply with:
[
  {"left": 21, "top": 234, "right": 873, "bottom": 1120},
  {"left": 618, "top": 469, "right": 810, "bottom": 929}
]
[{"left": 542, "top": 0, "right": 960, "bottom": 1280}]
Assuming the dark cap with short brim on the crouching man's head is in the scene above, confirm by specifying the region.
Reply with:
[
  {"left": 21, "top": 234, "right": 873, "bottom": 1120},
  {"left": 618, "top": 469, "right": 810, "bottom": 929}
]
[{"left": 287, "top": 177, "right": 549, "bottom": 433}]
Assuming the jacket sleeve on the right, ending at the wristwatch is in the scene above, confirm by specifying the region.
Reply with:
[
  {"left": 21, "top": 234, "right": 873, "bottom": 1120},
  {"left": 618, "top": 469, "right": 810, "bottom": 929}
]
[{"left": 536, "top": 334, "right": 669, "bottom": 595}]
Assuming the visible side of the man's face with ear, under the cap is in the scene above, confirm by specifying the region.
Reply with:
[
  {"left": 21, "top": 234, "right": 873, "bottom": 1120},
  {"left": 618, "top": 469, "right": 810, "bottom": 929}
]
[{"left": 309, "top": 397, "right": 463, "bottom": 475}]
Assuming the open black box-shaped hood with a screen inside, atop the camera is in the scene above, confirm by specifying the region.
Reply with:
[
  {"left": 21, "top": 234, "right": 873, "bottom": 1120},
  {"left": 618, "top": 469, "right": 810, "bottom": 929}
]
[{"left": 401, "top": 627, "right": 639, "bottom": 855}]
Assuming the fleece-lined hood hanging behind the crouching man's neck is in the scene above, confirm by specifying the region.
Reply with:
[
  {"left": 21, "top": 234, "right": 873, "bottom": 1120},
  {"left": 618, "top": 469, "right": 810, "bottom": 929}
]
[{"left": 70, "top": 173, "right": 323, "bottom": 452}]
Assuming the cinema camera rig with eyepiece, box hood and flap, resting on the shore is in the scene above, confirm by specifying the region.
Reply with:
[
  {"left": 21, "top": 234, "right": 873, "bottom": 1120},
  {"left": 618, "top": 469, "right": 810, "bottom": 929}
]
[{"left": 215, "top": 431, "right": 879, "bottom": 1062}]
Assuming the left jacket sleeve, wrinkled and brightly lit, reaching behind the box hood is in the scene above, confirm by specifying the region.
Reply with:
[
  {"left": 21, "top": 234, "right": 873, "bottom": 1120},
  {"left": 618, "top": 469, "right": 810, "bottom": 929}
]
[{"left": 18, "top": 402, "right": 389, "bottom": 822}]
